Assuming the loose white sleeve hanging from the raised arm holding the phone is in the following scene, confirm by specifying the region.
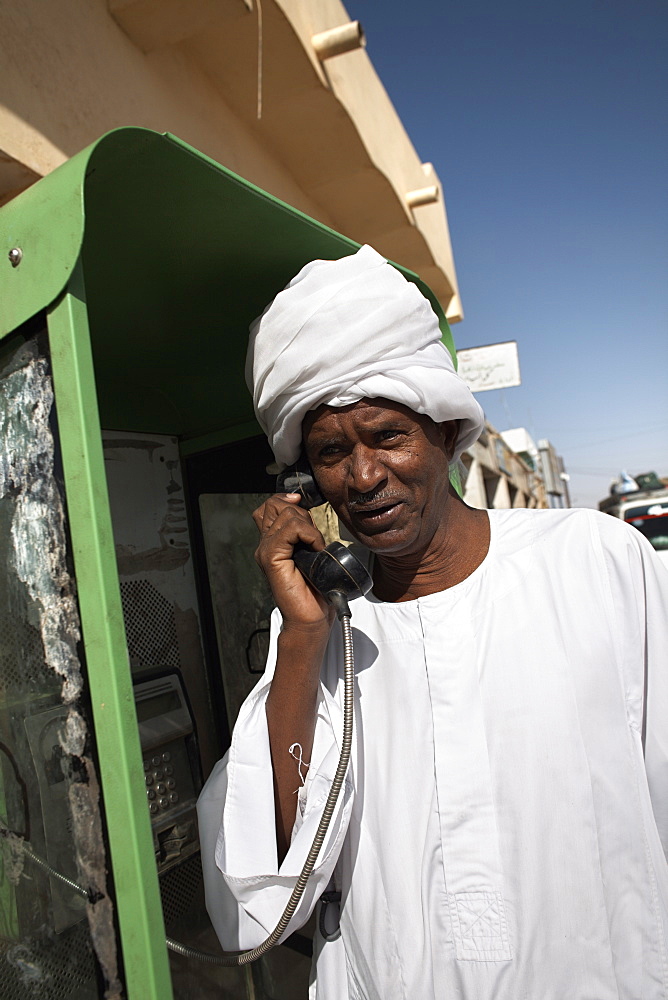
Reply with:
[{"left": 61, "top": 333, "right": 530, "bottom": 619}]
[{"left": 197, "top": 612, "right": 353, "bottom": 950}]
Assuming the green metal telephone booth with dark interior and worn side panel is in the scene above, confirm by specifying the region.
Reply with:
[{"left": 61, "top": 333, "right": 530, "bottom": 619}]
[{"left": 0, "top": 128, "right": 452, "bottom": 1000}]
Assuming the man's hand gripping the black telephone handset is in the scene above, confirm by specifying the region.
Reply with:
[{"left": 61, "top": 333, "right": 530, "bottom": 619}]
[{"left": 253, "top": 493, "right": 334, "bottom": 634}]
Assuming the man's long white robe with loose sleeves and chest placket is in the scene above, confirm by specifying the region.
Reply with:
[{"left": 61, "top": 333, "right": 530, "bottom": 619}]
[{"left": 199, "top": 510, "right": 668, "bottom": 1000}]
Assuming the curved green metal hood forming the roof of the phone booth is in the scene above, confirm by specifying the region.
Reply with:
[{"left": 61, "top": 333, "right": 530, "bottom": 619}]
[{"left": 0, "top": 129, "right": 454, "bottom": 450}]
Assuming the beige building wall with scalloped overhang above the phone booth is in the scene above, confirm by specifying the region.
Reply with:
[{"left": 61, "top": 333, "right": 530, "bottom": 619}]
[{"left": 0, "top": 0, "right": 461, "bottom": 321}]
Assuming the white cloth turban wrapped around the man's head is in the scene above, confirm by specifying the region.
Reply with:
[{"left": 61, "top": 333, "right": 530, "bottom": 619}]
[{"left": 246, "top": 246, "right": 484, "bottom": 466}]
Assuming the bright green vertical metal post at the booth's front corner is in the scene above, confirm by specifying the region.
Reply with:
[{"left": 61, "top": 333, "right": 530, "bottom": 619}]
[{"left": 48, "top": 268, "right": 172, "bottom": 1000}]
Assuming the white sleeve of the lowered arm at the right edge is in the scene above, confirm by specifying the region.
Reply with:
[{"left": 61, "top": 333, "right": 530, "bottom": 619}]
[{"left": 599, "top": 515, "right": 668, "bottom": 856}]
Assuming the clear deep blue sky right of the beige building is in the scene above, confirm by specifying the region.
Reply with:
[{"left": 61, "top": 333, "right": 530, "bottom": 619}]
[{"left": 346, "top": 0, "right": 668, "bottom": 506}]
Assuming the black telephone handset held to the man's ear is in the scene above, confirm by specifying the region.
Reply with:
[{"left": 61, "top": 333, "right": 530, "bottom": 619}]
[{"left": 276, "top": 455, "right": 373, "bottom": 617}]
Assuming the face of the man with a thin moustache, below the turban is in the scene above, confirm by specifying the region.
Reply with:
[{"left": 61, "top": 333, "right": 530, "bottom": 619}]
[{"left": 303, "top": 399, "right": 458, "bottom": 555}]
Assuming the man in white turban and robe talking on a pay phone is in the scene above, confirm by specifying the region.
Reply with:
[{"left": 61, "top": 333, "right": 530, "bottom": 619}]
[{"left": 200, "top": 247, "right": 668, "bottom": 1000}]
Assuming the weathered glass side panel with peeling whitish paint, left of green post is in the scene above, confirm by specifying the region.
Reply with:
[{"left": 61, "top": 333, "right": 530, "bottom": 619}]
[{"left": 0, "top": 333, "right": 123, "bottom": 1000}]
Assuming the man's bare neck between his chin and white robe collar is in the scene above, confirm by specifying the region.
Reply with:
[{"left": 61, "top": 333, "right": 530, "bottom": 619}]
[{"left": 373, "top": 493, "right": 490, "bottom": 602}]
